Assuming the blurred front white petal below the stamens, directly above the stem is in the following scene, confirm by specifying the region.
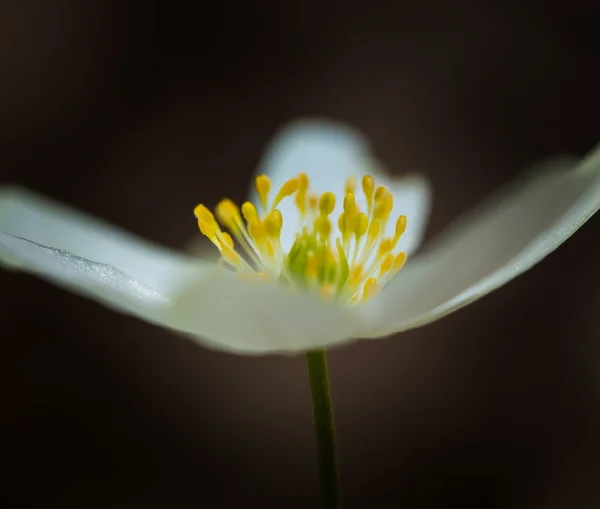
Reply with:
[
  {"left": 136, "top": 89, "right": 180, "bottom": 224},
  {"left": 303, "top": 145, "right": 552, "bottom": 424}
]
[{"left": 165, "top": 273, "right": 360, "bottom": 353}]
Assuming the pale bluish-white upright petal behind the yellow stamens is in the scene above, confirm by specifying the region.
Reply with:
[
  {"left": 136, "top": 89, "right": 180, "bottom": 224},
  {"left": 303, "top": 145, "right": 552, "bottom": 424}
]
[{"left": 251, "top": 120, "right": 430, "bottom": 254}]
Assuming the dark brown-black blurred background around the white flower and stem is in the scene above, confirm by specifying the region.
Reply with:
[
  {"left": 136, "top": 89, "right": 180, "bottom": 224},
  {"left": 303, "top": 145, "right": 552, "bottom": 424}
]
[{"left": 0, "top": 0, "right": 600, "bottom": 509}]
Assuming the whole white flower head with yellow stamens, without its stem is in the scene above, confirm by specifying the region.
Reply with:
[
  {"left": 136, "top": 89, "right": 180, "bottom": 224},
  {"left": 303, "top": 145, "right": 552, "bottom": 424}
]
[{"left": 0, "top": 122, "right": 600, "bottom": 353}]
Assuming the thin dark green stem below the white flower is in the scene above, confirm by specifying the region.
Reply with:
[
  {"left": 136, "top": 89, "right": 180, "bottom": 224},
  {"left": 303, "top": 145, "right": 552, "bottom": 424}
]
[{"left": 306, "top": 350, "right": 341, "bottom": 509}]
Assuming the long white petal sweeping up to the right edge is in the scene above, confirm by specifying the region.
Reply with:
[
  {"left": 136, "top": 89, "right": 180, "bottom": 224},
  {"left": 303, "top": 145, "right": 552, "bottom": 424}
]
[{"left": 359, "top": 148, "right": 600, "bottom": 337}]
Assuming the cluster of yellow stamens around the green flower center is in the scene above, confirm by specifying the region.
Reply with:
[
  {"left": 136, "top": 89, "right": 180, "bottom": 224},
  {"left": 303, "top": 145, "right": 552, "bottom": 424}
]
[{"left": 194, "top": 173, "right": 406, "bottom": 304}]
